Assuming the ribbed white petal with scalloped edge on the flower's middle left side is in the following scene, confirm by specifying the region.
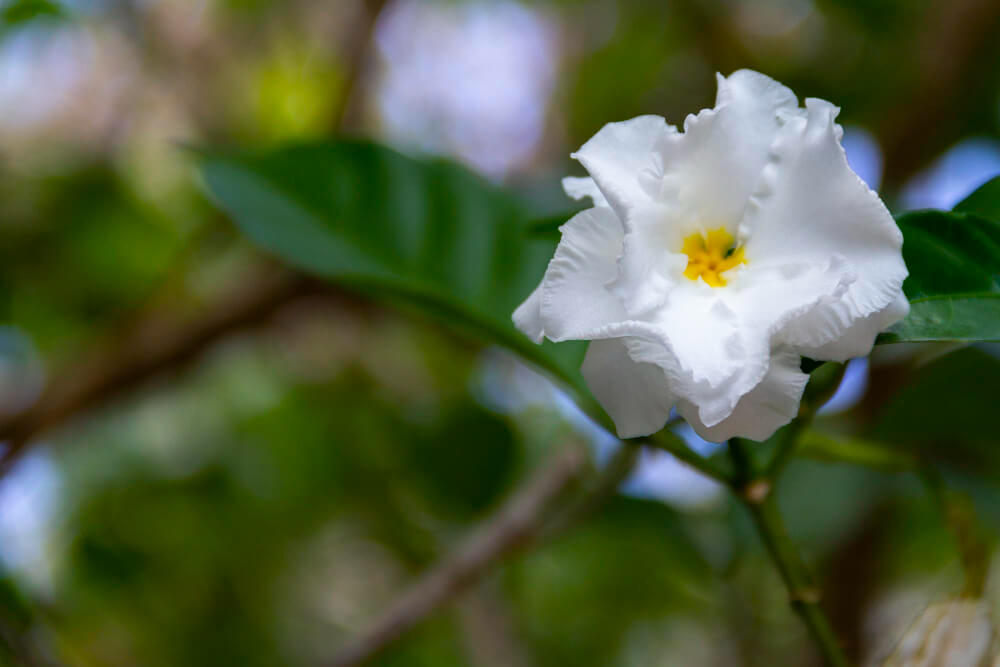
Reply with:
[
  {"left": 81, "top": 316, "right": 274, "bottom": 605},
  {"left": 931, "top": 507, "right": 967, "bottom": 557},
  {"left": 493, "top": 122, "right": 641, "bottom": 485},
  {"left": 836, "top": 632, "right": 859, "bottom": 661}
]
[{"left": 540, "top": 207, "right": 626, "bottom": 341}]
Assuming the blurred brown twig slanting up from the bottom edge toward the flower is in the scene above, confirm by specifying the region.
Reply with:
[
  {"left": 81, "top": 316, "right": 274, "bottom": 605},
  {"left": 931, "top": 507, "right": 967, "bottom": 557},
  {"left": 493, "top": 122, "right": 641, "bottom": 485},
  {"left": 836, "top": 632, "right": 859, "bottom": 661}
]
[{"left": 330, "top": 447, "right": 587, "bottom": 667}]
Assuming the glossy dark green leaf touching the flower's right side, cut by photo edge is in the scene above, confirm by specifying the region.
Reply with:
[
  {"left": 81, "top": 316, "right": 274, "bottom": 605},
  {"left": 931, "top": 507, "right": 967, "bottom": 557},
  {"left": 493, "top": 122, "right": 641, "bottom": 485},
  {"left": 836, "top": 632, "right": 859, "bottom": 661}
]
[{"left": 878, "top": 210, "right": 1000, "bottom": 343}]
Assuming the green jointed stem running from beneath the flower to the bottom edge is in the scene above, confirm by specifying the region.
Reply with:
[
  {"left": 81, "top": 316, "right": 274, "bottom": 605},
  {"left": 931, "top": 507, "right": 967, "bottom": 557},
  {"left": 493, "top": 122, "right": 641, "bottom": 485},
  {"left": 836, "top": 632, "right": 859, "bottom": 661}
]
[{"left": 729, "top": 438, "right": 851, "bottom": 667}]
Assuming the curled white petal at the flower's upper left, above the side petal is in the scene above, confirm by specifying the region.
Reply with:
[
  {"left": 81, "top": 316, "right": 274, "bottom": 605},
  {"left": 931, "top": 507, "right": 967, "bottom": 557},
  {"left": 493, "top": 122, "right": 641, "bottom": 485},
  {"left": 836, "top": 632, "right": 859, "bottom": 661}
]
[{"left": 572, "top": 116, "right": 676, "bottom": 218}]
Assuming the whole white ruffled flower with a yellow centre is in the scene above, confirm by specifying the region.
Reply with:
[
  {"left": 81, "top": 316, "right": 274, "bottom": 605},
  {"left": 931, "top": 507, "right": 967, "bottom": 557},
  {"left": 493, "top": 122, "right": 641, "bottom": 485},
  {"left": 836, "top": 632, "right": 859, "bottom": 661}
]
[{"left": 514, "top": 70, "right": 909, "bottom": 441}]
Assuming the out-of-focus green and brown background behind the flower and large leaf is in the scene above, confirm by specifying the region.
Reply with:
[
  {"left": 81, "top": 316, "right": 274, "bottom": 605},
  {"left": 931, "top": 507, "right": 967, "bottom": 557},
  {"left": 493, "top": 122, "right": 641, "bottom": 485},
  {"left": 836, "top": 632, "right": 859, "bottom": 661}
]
[{"left": 0, "top": 0, "right": 1000, "bottom": 667}]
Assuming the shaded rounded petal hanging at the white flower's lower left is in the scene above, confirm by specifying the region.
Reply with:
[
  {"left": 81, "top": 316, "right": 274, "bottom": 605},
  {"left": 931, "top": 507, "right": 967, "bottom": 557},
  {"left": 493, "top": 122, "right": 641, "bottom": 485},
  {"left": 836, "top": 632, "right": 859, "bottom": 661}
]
[{"left": 580, "top": 338, "right": 674, "bottom": 438}]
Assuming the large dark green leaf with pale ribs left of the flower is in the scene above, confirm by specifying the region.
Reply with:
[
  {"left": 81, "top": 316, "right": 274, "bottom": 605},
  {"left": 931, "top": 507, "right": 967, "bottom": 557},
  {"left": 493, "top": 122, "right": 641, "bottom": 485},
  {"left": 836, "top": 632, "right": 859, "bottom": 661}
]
[{"left": 199, "top": 141, "right": 583, "bottom": 389}]
